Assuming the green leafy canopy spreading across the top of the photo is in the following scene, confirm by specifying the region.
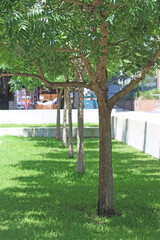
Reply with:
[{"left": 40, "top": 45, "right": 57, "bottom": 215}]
[{"left": 0, "top": 0, "right": 160, "bottom": 82}]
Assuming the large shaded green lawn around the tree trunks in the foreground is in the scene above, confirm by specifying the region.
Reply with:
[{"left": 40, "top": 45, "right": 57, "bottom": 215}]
[{"left": 0, "top": 136, "right": 160, "bottom": 240}]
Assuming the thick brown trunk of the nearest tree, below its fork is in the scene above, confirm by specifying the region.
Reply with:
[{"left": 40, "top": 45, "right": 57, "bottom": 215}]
[{"left": 98, "top": 96, "right": 115, "bottom": 217}]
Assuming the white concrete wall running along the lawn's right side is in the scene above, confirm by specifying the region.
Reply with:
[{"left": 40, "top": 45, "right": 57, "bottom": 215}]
[{"left": 112, "top": 113, "right": 160, "bottom": 159}]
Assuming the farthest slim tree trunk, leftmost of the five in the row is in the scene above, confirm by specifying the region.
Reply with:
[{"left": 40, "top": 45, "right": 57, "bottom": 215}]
[{"left": 56, "top": 89, "right": 62, "bottom": 140}]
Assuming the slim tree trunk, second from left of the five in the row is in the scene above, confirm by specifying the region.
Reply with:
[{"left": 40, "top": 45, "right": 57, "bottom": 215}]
[{"left": 62, "top": 88, "right": 67, "bottom": 147}]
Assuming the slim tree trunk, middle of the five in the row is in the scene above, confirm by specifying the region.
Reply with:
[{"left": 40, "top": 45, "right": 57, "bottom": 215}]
[{"left": 67, "top": 88, "right": 73, "bottom": 158}]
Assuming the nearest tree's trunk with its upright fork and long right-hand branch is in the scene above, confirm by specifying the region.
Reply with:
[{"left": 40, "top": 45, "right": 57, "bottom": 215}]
[{"left": 83, "top": 46, "right": 160, "bottom": 217}]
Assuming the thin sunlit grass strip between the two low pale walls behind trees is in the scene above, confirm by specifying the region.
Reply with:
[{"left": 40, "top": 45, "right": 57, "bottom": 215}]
[{"left": 0, "top": 123, "right": 99, "bottom": 128}]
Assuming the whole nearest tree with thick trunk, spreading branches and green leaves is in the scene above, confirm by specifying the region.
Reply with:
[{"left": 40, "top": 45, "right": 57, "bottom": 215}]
[{"left": 0, "top": 0, "right": 160, "bottom": 217}]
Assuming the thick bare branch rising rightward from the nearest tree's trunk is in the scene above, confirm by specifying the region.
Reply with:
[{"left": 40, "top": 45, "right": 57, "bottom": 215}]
[{"left": 109, "top": 48, "right": 160, "bottom": 107}]
